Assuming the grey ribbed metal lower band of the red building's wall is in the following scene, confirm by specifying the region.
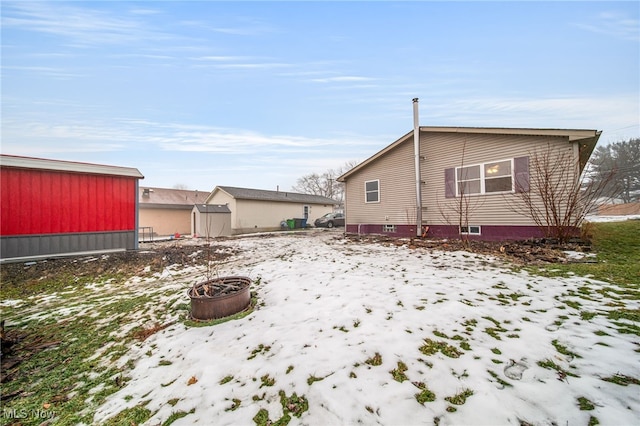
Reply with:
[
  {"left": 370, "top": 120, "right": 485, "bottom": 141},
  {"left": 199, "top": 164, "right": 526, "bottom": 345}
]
[{"left": 0, "top": 231, "right": 138, "bottom": 260}]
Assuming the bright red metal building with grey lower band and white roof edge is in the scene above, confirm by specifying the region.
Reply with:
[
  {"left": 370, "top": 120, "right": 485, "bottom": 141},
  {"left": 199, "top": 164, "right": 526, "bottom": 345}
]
[{"left": 0, "top": 155, "right": 143, "bottom": 260}]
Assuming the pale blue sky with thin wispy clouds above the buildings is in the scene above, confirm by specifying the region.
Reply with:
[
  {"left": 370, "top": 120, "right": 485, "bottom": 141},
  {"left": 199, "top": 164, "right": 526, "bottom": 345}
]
[{"left": 1, "top": 1, "right": 640, "bottom": 191}]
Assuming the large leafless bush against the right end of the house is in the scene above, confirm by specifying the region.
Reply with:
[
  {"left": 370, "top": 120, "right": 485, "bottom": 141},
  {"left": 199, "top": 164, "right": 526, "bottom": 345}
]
[{"left": 508, "top": 145, "right": 615, "bottom": 242}]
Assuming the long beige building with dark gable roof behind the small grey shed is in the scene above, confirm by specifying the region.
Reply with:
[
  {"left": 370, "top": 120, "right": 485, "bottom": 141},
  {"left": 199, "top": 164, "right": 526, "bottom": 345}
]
[{"left": 205, "top": 186, "right": 338, "bottom": 234}]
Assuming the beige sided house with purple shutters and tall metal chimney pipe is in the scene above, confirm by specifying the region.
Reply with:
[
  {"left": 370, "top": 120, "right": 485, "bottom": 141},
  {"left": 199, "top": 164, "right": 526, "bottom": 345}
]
[{"left": 338, "top": 126, "right": 601, "bottom": 240}]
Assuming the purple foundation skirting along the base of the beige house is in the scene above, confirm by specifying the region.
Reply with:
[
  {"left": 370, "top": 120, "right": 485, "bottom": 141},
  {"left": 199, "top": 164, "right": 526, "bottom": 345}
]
[{"left": 346, "top": 224, "right": 580, "bottom": 241}]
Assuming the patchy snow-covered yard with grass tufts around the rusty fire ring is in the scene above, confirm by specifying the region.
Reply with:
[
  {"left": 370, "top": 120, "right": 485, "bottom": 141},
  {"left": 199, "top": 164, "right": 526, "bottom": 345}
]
[{"left": 95, "top": 232, "right": 640, "bottom": 425}]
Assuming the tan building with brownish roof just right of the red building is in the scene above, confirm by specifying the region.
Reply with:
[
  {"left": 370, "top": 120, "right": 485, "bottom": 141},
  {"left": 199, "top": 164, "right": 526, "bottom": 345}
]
[{"left": 138, "top": 186, "right": 209, "bottom": 241}]
